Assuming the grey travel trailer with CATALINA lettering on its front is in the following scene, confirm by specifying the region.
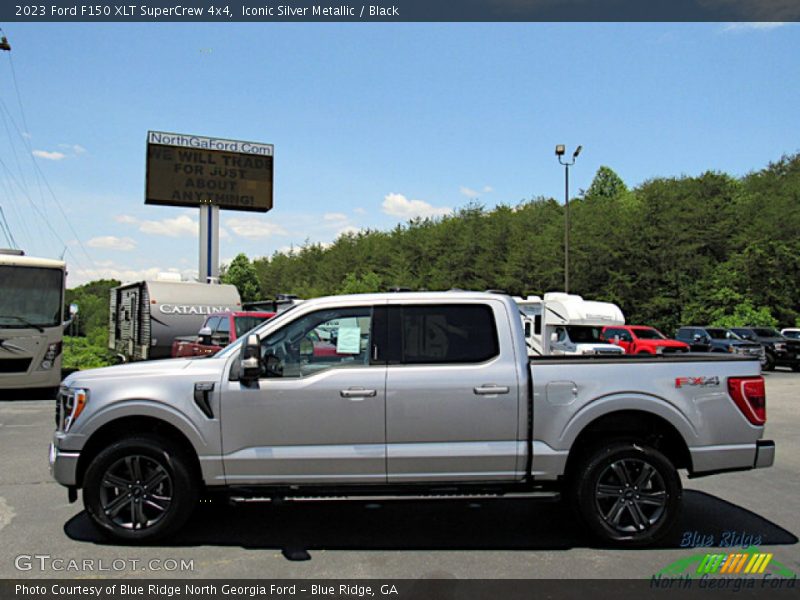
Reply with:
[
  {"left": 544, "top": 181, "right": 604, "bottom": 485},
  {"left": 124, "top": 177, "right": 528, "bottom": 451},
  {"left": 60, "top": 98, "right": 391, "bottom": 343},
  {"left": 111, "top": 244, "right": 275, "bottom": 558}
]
[{"left": 108, "top": 281, "right": 242, "bottom": 361}]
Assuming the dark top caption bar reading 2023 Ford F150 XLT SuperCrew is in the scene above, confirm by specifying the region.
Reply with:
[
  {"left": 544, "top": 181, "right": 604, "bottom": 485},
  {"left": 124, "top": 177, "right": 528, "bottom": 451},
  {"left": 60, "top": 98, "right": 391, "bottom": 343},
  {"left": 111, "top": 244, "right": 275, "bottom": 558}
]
[{"left": 6, "top": 0, "right": 800, "bottom": 23}]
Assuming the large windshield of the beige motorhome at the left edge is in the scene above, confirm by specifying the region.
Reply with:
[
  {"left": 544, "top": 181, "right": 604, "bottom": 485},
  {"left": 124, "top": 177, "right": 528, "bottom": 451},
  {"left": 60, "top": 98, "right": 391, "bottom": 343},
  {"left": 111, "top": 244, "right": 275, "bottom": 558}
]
[{"left": 0, "top": 265, "right": 64, "bottom": 329}]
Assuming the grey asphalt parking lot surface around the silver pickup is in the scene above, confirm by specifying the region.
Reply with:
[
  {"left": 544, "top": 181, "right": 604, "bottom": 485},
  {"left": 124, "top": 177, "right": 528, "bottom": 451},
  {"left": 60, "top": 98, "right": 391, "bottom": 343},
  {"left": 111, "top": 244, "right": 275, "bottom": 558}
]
[{"left": 0, "top": 370, "right": 800, "bottom": 579}]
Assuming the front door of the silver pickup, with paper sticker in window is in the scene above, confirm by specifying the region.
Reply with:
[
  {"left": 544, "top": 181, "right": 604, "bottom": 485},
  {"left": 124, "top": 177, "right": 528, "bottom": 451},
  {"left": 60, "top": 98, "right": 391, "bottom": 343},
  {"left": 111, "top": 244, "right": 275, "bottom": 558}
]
[{"left": 216, "top": 306, "right": 386, "bottom": 485}]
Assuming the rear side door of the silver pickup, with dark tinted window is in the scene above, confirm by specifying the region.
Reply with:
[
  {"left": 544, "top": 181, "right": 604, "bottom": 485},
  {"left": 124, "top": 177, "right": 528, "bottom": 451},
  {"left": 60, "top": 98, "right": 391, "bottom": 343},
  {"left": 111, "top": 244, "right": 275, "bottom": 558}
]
[{"left": 386, "top": 300, "right": 527, "bottom": 483}]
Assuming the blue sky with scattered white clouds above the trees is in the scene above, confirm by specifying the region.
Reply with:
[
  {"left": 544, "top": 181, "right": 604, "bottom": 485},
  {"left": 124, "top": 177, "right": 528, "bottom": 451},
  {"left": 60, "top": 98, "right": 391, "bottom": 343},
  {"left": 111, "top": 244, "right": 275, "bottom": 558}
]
[{"left": 0, "top": 23, "right": 800, "bottom": 286}]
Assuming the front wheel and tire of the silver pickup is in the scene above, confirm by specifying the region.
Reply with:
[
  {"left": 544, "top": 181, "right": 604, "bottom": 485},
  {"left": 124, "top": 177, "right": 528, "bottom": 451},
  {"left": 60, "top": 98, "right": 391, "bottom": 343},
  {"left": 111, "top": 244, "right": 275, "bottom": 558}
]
[{"left": 83, "top": 435, "right": 199, "bottom": 542}]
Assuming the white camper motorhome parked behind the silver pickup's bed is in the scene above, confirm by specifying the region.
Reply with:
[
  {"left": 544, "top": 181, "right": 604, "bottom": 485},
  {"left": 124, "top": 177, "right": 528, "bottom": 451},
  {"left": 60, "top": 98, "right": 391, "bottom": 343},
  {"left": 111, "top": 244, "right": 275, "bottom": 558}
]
[{"left": 515, "top": 292, "right": 625, "bottom": 356}]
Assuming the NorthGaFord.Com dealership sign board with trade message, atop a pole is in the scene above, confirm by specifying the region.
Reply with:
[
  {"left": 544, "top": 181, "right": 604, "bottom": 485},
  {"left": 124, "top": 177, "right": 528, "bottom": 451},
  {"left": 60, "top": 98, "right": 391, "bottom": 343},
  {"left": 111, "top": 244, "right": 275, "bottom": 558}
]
[{"left": 145, "top": 131, "right": 274, "bottom": 212}]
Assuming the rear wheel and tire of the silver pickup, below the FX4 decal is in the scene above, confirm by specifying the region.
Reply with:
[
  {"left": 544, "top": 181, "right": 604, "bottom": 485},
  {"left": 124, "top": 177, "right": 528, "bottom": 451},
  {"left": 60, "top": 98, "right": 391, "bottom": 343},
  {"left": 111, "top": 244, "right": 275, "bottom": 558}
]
[{"left": 571, "top": 442, "right": 683, "bottom": 547}]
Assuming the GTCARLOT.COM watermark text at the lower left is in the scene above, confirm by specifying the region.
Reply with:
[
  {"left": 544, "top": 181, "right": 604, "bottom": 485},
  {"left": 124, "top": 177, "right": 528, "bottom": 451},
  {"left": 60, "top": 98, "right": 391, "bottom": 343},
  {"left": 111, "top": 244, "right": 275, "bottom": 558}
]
[{"left": 14, "top": 554, "right": 194, "bottom": 573}]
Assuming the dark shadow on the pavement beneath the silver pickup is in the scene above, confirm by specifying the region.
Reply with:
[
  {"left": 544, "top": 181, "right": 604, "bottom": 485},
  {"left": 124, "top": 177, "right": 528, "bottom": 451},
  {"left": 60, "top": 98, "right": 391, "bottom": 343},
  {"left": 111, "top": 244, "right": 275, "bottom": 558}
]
[{"left": 64, "top": 490, "right": 798, "bottom": 560}]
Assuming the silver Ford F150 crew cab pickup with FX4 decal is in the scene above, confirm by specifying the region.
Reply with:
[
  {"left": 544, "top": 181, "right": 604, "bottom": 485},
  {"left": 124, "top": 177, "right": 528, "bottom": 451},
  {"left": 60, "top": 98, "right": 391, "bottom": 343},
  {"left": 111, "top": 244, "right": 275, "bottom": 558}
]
[{"left": 50, "top": 292, "right": 775, "bottom": 546}]
